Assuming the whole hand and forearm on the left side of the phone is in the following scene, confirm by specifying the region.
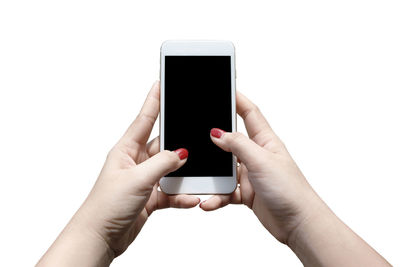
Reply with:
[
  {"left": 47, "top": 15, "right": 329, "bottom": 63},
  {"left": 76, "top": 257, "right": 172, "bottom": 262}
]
[{"left": 38, "top": 82, "right": 200, "bottom": 266}]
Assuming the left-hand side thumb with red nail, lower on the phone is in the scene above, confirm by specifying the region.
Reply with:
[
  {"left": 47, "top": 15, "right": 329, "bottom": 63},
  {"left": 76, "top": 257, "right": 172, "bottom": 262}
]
[{"left": 135, "top": 148, "right": 189, "bottom": 185}]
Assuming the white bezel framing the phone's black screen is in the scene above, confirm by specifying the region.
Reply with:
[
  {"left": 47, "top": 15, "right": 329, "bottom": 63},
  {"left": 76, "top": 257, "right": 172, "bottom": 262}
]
[{"left": 160, "top": 40, "right": 237, "bottom": 194}]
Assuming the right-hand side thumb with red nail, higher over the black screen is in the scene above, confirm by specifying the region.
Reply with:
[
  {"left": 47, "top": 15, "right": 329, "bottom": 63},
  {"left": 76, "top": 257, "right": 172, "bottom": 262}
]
[{"left": 210, "top": 128, "right": 265, "bottom": 169}]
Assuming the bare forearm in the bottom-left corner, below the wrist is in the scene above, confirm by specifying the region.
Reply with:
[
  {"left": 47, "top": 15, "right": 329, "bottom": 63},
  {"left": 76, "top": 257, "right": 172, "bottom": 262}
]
[{"left": 36, "top": 207, "right": 113, "bottom": 267}]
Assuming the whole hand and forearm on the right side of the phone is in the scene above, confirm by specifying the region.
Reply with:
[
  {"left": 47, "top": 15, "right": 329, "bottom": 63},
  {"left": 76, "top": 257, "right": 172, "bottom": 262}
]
[{"left": 200, "top": 93, "right": 390, "bottom": 266}]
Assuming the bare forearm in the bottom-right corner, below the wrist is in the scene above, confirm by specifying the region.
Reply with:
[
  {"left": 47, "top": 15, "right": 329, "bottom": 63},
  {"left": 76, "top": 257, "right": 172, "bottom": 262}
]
[{"left": 288, "top": 200, "right": 391, "bottom": 266}]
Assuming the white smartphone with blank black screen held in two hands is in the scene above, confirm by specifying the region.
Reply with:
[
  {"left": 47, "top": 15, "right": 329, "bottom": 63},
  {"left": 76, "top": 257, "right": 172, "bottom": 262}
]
[{"left": 160, "top": 41, "right": 237, "bottom": 194}]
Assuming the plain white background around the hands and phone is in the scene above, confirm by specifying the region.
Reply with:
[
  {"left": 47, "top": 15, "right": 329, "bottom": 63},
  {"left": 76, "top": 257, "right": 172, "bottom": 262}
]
[{"left": 0, "top": 0, "right": 400, "bottom": 266}]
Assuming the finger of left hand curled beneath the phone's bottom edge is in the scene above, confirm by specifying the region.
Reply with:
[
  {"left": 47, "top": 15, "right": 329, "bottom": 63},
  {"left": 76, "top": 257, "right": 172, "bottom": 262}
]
[{"left": 157, "top": 191, "right": 200, "bottom": 209}]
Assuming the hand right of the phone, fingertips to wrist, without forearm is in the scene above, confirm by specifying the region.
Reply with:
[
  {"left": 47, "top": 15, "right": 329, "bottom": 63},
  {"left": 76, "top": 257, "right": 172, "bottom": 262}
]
[{"left": 200, "top": 92, "right": 322, "bottom": 244}]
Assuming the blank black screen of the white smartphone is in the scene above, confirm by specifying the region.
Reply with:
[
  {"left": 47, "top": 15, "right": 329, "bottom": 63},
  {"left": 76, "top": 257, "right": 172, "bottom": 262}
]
[{"left": 164, "top": 56, "right": 233, "bottom": 177}]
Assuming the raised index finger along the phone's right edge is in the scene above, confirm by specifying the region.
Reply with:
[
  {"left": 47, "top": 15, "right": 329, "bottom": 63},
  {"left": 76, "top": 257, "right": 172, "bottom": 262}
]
[{"left": 236, "top": 92, "right": 275, "bottom": 146}]
